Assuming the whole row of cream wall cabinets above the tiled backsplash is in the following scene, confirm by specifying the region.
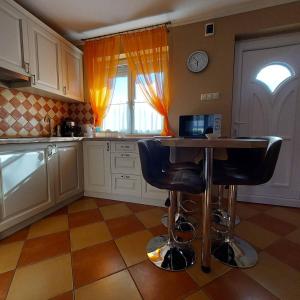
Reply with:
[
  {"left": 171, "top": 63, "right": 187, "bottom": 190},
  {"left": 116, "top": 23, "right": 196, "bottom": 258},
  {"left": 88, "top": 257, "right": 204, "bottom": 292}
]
[{"left": 0, "top": 0, "right": 84, "bottom": 101}]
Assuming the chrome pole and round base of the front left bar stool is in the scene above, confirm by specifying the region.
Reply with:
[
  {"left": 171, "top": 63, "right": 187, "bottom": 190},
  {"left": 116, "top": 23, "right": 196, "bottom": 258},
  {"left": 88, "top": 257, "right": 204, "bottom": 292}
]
[{"left": 147, "top": 191, "right": 195, "bottom": 271}]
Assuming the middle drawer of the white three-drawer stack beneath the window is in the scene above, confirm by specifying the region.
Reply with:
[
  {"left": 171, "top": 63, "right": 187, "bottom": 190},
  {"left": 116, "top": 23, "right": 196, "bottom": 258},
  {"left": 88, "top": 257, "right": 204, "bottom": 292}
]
[{"left": 111, "top": 153, "right": 140, "bottom": 175}]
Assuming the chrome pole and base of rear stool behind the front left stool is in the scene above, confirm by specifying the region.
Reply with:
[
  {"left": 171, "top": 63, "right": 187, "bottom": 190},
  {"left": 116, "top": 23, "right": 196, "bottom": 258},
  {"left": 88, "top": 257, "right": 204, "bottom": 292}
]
[{"left": 161, "top": 192, "right": 199, "bottom": 232}]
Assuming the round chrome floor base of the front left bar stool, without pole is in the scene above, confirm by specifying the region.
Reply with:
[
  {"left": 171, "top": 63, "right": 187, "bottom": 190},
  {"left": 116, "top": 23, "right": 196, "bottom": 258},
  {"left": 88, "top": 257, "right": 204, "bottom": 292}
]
[{"left": 146, "top": 235, "right": 195, "bottom": 271}]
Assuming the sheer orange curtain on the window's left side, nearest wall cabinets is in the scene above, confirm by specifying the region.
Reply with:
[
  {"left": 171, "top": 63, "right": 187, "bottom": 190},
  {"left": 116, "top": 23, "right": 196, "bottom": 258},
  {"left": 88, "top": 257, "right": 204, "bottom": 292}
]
[{"left": 84, "top": 36, "right": 120, "bottom": 126}]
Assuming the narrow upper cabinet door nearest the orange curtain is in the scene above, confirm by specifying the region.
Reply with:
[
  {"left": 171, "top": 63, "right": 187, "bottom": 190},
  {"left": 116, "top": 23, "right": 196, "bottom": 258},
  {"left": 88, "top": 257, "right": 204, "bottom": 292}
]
[{"left": 62, "top": 45, "right": 83, "bottom": 101}]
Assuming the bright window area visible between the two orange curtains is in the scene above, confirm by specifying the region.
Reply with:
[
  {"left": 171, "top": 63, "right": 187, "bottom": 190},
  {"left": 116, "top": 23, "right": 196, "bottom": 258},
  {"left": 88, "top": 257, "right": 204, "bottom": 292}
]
[{"left": 103, "top": 62, "right": 163, "bottom": 134}]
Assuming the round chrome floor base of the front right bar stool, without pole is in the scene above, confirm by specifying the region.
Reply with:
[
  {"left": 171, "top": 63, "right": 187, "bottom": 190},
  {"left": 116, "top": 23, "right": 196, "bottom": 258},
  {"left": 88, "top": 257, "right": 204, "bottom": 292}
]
[{"left": 212, "top": 236, "right": 257, "bottom": 268}]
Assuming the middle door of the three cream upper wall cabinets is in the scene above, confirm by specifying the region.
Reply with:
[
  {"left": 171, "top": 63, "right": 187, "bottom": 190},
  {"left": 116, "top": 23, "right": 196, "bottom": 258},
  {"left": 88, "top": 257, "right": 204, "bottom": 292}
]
[{"left": 29, "top": 22, "right": 62, "bottom": 95}]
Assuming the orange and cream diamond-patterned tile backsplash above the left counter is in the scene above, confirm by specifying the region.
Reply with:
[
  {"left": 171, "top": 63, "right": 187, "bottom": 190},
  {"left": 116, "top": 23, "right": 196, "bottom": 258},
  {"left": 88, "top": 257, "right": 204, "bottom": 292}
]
[{"left": 0, "top": 87, "right": 70, "bottom": 137}]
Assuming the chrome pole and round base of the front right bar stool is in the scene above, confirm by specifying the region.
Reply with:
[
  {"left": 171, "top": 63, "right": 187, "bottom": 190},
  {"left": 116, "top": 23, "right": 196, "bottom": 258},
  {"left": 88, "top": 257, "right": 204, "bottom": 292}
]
[{"left": 212, "top": 185, "right": 257, "bottom": 268}]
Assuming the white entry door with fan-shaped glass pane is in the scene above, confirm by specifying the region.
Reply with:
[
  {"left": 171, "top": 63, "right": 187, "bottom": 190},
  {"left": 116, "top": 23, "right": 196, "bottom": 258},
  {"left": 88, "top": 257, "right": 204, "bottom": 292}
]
[{"left": 232, "top": 34, "right": 300, "bottom": 207}]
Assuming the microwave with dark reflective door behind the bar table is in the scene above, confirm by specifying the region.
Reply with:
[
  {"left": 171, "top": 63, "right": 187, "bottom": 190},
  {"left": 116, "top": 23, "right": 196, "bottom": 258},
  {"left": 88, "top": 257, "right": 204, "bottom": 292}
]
[{"left": 179, "top": 114, "right": 222, "bottom": 138}]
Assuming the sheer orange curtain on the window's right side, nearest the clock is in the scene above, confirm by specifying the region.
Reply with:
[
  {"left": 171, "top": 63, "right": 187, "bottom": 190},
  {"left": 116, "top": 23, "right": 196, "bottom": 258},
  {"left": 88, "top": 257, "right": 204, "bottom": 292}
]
[{"left": 122, "top": 27, "right": 174, "bottom": 135}]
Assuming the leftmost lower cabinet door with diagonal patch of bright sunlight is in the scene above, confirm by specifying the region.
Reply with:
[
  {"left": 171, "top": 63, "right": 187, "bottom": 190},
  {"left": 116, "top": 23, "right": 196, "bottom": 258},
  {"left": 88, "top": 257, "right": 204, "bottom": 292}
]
[{"left": 0, "top": 145, "right": 54, "bottom": 231}]
